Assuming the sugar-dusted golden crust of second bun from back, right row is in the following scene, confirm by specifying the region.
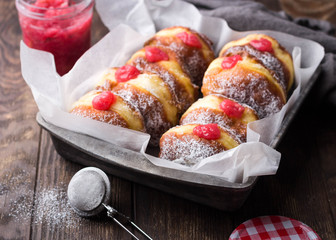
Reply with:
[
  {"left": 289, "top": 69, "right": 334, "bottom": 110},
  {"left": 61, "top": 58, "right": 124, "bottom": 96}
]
[{"left": 201, "top": 57, "right": 286, "bottom": 118}]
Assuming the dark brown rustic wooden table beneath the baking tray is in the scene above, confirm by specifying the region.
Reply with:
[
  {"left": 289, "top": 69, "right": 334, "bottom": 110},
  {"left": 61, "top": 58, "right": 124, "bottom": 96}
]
[{"left": 0, "top": 0, "right": 336, "bottom": 240}]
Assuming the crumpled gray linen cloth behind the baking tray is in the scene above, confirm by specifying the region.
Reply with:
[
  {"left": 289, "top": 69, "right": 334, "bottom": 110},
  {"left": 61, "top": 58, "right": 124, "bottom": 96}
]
[{"left": 187, "top": 0, "right": 336, "bottom": 107}]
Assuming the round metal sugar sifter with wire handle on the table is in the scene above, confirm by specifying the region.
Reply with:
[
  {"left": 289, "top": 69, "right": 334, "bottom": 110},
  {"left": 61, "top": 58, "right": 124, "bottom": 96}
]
[{"left": 68, "top": 167, "right": 152, "bottom": 240}]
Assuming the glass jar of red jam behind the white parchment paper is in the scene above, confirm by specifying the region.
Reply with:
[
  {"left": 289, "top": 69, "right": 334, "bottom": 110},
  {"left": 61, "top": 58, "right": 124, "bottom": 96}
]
[{"left": 16, "top": 0, "right": 94, "bottom": 75}]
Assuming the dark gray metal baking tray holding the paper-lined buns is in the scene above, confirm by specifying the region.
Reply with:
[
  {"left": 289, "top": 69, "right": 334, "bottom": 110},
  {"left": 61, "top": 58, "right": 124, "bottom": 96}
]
[{"left": 36, "top": 68, "right": 320, "bottom": 211}]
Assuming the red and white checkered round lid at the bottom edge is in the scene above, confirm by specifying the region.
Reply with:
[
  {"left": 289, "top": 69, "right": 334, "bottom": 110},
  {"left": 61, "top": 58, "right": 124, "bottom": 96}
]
[{"left": 229, "top": 216, "right": 321, "bottom": 240}]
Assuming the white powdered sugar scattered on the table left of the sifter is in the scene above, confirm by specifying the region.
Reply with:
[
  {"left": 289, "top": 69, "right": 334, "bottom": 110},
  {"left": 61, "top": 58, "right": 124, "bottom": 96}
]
[{"left": 9, "top": 184, "right": 85, "bottom": 228}]
